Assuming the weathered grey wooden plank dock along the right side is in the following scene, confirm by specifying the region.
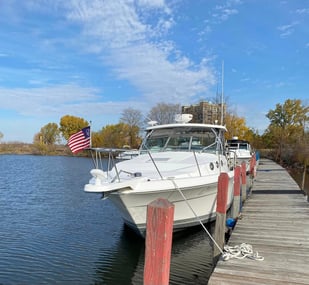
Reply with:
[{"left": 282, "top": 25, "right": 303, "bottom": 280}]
[{"left": 208, "top": 159, "right": 309, "bottom": 285}]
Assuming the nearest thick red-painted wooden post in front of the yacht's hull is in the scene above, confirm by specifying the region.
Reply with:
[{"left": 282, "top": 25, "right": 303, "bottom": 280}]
[{"left": 144, "top": 198, "right": 174, "bottom": 285}]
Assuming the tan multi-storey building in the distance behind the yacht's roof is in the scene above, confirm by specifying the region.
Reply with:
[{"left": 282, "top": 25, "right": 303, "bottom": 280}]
[{"left": 181, "top": 101, "right": 226, "bottom": 124}]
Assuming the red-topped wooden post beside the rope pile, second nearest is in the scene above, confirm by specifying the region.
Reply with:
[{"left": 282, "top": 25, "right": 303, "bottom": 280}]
[{"left": 214, "top": 173, "right": 229, "bottom": 257}]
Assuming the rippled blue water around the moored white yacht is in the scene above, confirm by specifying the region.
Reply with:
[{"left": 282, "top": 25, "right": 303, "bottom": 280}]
[{"left": 0, "top": 155, "right": 213, "bottom": 285}]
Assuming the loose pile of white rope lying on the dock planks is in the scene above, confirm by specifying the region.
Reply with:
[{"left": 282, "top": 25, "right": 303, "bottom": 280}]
[{"left": 222, "top": 243, "right": 264, "bottom": 261}]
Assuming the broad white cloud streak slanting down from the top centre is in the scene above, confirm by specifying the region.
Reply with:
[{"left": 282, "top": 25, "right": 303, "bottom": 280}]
[{"left": 62, "top": 0, "right": 214, "bottom": 103}]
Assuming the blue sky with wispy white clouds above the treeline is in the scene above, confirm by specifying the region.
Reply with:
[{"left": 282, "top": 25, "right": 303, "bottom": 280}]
[{"left": 0, "top": 0, "right": 309, "bottom": 142}]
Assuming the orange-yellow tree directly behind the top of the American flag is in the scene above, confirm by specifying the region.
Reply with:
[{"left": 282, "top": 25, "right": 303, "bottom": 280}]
[{"left": 59, "top": 115, "right": 89, "bottom": 140}]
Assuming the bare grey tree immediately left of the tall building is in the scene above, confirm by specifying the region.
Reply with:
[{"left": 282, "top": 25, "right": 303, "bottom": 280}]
[{"left": 147, "top": 103, "right": 181, "bottom": 125}]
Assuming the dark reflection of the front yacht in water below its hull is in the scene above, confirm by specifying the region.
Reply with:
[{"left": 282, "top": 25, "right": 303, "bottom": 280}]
[{"left": 95, "top": 223, "right": 214, "bottom": 285}]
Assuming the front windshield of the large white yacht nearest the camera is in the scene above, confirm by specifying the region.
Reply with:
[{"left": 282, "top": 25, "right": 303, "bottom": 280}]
[{"left": 141, "top": 126, "right": 222, "bottom": 153}]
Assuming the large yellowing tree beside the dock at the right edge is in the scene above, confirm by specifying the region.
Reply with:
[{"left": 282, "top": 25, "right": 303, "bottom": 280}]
[{"left": 265, "top": 99, "right": 309, "bottom": 162}]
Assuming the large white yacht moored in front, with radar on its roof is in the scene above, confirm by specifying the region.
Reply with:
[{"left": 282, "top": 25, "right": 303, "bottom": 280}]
[{"left": 84, "top": 114, "right": 234, "bottom": 236}]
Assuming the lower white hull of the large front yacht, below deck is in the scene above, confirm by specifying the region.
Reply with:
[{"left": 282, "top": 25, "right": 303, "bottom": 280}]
[{"left": 102, "top": 175, "right": 233, "bottom": 236}]
